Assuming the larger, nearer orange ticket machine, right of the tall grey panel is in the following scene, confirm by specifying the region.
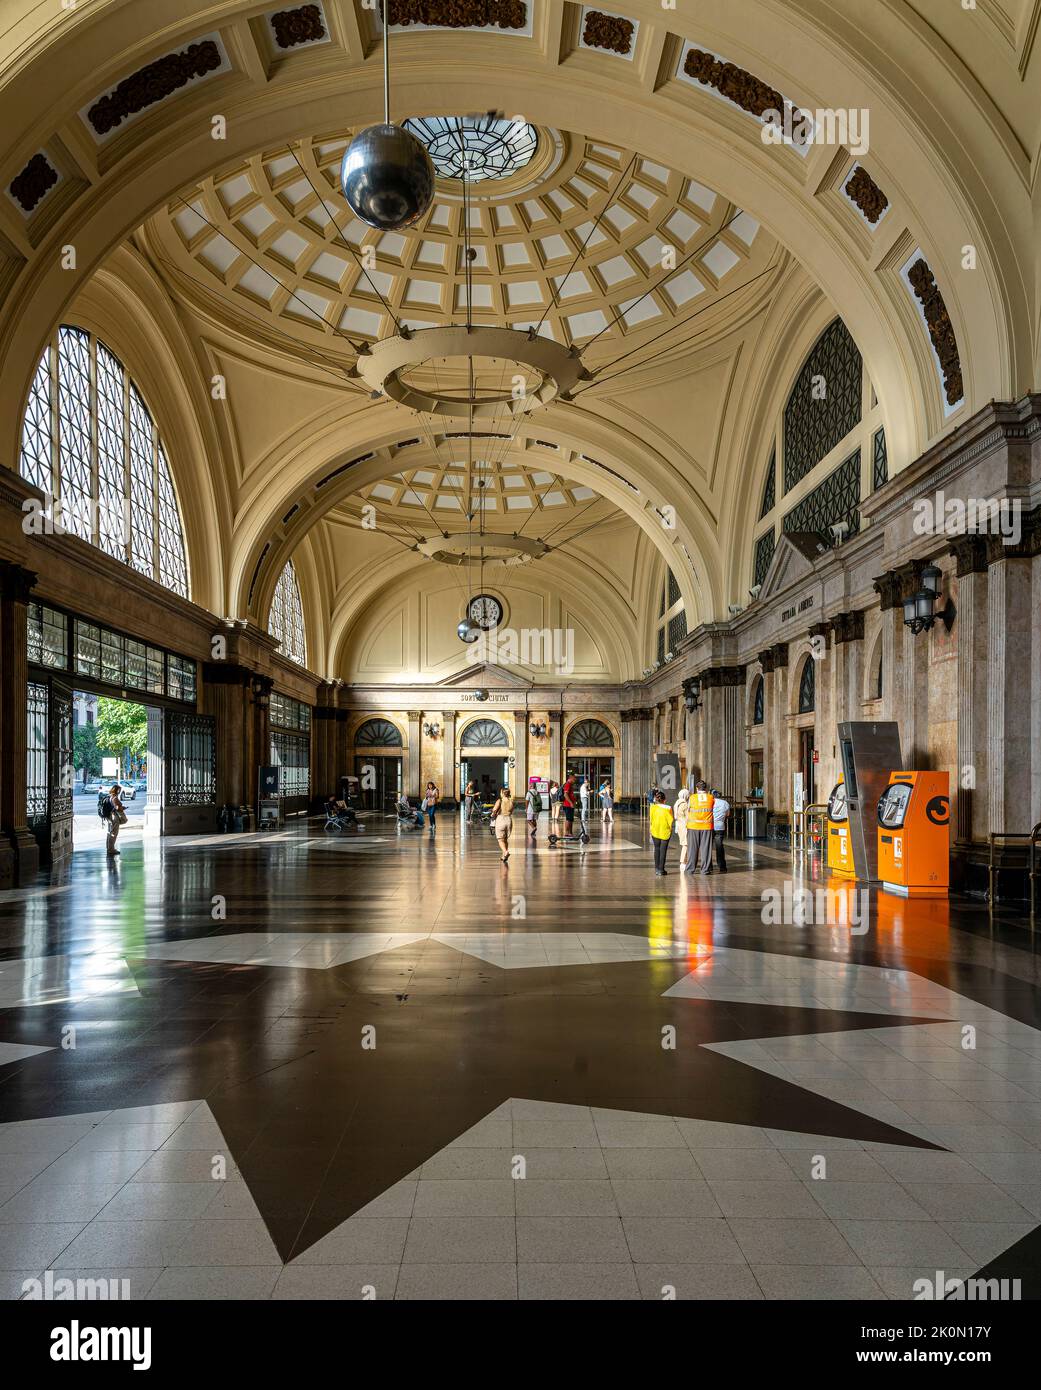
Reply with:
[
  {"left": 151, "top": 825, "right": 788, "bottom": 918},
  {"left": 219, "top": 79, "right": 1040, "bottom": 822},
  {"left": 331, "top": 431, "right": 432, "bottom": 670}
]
[{"left": 878, "top": 773, "right": 951, "bottom": 898}]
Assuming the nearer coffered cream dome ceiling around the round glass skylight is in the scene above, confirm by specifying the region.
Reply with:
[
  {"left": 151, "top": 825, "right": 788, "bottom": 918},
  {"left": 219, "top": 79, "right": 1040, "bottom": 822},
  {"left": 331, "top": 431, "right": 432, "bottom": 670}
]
[{"left": 145, "top": 117, "right": 784, "bottom": 364}]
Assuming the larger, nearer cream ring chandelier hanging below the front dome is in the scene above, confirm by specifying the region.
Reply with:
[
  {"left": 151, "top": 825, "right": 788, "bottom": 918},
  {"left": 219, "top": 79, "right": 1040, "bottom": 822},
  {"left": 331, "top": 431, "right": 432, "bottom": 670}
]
[{"left": 354, "top": 324, "right": 589, "bottom": 420}]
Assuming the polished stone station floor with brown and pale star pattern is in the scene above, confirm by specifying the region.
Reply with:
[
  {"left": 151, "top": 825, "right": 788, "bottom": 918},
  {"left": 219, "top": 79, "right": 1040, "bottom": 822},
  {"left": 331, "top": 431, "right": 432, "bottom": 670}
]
[{"left": 0, "top": 813, "right": 1041, "bottom": 1300}]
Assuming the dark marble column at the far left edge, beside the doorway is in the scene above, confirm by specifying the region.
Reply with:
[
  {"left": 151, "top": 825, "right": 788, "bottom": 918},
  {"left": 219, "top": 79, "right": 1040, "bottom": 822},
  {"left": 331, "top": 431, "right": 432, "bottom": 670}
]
[{"left": 0, "top": 560, "right": 40, "bottom": 888}]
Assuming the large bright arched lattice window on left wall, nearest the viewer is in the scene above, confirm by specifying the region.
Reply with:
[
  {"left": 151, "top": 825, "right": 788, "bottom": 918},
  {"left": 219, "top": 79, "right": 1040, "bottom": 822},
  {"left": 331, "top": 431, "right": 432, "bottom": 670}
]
[{"left": 19, "top": 324, "right": 188, "bottom": 598}]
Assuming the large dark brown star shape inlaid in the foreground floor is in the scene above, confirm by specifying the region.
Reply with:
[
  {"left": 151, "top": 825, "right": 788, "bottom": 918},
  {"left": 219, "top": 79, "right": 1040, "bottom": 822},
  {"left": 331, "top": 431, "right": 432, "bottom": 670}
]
[{"left": 6, "top": 938, "right": 933, "bottom": 1261}]
